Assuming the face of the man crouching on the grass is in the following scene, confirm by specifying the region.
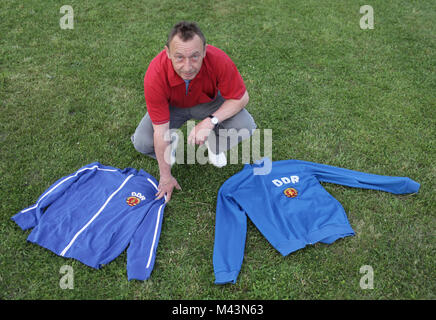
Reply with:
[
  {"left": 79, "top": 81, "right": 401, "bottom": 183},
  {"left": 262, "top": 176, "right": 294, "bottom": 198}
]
[{"left": 165, "top": 35, "right": 206, "bottom": 80}]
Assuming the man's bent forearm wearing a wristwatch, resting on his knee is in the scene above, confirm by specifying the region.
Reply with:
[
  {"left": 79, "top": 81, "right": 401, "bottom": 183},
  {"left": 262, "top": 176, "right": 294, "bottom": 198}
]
[{"left": 188, "top": 91, "right": 249, "bottom": 145}]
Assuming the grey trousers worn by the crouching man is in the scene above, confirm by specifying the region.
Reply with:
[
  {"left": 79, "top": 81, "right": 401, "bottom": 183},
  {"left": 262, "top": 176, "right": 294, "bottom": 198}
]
[{"left": 131, "top": 95, "right": 256, "bottom": 159}]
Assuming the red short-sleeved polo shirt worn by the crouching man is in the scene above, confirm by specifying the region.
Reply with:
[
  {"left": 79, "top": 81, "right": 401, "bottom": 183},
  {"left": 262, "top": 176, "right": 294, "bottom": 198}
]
[{"left": 144, "top": 45, "right": 246, "bottom": 124}]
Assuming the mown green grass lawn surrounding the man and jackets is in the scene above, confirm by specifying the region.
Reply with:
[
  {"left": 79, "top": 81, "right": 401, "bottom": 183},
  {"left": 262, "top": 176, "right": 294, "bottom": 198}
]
[{"left": 0, "top": 0, "right": 436, "bottom": 299}]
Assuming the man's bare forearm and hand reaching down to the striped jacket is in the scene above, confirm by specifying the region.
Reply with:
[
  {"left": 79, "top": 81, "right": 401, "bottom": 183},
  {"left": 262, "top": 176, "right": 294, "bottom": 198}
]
[{"left": 153, "top": 122, "right": 181, "bottom": 202}]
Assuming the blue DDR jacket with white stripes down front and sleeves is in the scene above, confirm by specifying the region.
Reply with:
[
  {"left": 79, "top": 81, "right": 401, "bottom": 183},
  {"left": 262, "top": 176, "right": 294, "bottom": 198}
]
[{"left": 12, "top": 162, "right": 165, "bottom": 280}]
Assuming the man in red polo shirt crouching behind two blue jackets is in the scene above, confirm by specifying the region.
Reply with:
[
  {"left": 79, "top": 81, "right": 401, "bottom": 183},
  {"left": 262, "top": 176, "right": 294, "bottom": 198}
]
[{"left": 131, "top": 21, "right": 256, "bottom": 202}]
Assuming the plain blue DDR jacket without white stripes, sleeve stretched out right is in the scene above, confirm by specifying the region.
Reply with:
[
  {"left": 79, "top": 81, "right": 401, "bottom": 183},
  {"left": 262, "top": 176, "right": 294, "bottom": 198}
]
[{"left": 213, "top": 158, "right": 420, "bottom": 284}]
